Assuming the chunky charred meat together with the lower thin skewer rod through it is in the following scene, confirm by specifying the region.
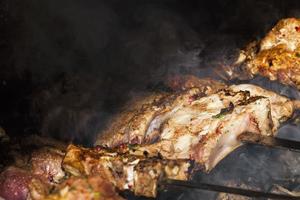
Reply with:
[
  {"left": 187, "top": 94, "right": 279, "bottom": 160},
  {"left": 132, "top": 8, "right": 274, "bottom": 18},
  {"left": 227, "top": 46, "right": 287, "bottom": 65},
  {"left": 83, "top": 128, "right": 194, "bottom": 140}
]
[{"left": 59, "top": 145, "right": 300, "bottom": 200}]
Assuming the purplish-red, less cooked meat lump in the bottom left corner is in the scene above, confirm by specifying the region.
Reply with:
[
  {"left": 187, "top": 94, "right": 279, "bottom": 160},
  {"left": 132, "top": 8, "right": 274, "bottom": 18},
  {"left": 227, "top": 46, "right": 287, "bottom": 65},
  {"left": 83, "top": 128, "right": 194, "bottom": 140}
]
[{"left": 0, "top": 141, "right": 65, "bottom": 200}]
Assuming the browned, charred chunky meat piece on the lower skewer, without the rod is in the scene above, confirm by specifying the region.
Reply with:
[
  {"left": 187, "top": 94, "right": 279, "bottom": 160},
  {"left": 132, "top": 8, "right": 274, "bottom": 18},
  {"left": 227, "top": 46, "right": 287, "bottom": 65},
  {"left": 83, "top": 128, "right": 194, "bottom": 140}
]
[{"left": 63, "top": 145, "right": 190, "bottom": 197}]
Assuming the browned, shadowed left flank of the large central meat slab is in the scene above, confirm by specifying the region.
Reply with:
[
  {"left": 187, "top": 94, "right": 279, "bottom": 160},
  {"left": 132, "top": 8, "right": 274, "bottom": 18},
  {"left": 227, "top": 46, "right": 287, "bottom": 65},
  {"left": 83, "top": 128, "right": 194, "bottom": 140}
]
[{"left": 95, "top": 88, "right": 204, "bottom": 147}]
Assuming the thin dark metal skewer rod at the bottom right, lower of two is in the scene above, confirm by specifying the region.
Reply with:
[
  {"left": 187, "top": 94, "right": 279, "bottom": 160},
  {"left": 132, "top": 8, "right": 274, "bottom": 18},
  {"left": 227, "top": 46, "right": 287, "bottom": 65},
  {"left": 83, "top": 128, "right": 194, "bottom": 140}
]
[{"left": 161, "top": 179, "right": 300, "bottom": 200}]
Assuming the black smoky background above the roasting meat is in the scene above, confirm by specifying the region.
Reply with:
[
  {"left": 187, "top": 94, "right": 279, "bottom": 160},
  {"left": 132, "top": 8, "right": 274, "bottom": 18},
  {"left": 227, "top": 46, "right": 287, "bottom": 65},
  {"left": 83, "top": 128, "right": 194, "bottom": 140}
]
[{"left": 0, "top": 0, "right": 300, "bottom": 144}]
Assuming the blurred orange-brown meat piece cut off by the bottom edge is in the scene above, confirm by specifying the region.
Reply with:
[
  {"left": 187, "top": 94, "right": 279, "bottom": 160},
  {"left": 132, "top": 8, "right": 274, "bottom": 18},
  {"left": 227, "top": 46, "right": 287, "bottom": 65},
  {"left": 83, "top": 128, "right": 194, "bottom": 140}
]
[{"left": 43, "top": 175, "right": 123, "bottom": 200}]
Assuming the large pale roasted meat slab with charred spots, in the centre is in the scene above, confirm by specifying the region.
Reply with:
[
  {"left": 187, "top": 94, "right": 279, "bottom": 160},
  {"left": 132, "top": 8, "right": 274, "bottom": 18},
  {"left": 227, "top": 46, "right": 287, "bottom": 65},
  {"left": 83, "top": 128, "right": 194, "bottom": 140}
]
[{"left": 96, "top": 84, "right": 295, "bottom": 171}]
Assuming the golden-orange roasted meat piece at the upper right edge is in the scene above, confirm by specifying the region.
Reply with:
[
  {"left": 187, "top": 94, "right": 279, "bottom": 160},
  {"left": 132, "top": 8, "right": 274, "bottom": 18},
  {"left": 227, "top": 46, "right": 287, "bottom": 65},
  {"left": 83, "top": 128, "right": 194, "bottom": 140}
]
[{"left": 238, "top": 18, "right": 300, "bottom": 89}]
